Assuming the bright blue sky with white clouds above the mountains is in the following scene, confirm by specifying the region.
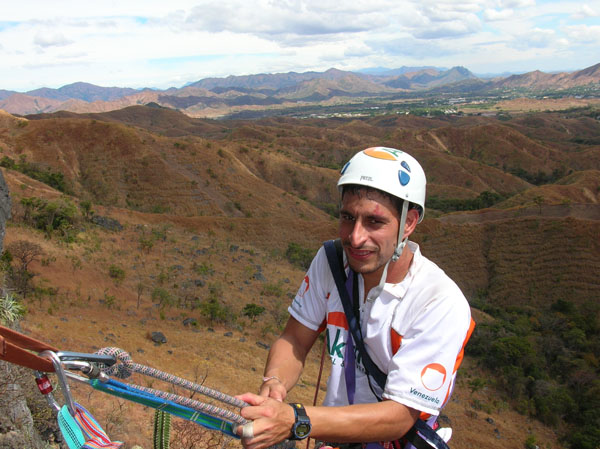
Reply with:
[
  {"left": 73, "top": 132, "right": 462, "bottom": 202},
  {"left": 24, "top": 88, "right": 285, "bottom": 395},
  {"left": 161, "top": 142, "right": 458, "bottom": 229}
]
[{"left": 0, "top": 0, "right": 600, "bottom": 92}]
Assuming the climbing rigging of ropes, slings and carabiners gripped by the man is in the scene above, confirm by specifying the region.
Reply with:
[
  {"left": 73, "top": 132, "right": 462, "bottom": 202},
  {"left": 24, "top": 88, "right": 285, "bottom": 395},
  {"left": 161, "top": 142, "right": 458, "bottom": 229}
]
[{"left": 0, "top": 326, "right": 294, "bottom": 449}]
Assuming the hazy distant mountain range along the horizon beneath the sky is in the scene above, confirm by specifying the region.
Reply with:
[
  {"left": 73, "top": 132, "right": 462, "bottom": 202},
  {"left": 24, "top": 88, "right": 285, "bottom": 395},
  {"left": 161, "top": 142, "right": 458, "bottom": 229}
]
[{"left": 0, "top": 64, "right": 600, "bottom": 117}]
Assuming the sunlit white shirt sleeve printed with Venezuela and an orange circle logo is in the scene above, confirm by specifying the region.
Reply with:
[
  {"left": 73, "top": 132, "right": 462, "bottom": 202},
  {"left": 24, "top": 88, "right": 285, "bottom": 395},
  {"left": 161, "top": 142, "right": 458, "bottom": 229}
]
[{"left": 383, "top": 285, "right": 471, "bottom": 415}]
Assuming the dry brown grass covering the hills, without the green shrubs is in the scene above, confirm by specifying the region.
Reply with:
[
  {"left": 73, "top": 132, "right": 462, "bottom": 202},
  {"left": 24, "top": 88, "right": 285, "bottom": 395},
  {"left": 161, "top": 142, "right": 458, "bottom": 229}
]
[{"left": 0, "top": 108, "right": 600, "bottom": 449}]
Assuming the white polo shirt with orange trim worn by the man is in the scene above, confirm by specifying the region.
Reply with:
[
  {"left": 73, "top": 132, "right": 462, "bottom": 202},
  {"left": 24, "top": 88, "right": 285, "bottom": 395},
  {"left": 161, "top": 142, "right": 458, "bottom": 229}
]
[{"left": 288, "top": 242, "right": 471, "bottom": 415}]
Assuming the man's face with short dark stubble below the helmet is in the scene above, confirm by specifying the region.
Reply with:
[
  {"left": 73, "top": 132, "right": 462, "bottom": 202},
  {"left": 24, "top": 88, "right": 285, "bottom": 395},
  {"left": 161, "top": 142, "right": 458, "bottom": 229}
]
[{"left": 339, "top": 190, "right": 400, "bottom": 277}]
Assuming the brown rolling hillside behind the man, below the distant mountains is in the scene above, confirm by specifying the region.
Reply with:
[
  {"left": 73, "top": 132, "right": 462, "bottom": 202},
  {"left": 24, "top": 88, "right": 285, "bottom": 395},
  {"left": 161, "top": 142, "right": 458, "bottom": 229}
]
[{"left": 0, "top": 106, "right": 600, "bottom": 449}]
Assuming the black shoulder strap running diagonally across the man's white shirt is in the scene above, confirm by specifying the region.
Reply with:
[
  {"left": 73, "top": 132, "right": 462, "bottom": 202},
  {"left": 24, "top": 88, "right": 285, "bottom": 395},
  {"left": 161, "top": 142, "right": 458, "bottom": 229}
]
[{"left": 323, "top": 239, "right": 450, "bottom": 449}]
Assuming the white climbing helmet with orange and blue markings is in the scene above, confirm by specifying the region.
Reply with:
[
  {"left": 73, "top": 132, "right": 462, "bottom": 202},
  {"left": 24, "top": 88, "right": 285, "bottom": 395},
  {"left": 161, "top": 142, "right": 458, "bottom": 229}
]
[{"left": 338, "top": 147, "right": 426, "bottom": 223}]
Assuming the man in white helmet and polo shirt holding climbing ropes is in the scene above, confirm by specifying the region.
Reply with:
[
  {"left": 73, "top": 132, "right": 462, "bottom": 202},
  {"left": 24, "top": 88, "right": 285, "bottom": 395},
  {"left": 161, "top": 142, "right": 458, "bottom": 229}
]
[{"left": 239, "top": 147, "right": 472, "bottom": 449}]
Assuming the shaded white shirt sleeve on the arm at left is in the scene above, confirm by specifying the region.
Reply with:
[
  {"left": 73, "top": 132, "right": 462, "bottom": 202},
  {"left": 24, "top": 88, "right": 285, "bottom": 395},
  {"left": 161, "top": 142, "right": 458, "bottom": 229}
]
[{"left": 288, "top": 247, "right": 331, "bottom": 331}]
